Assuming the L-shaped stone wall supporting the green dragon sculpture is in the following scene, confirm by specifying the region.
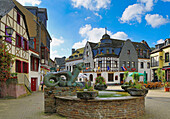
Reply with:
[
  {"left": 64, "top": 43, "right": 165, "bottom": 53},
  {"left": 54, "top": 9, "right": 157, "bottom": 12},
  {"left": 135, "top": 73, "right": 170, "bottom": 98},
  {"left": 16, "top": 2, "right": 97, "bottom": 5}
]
[{"left": 44, "top": 87, "right": 77, "bottom": 113}]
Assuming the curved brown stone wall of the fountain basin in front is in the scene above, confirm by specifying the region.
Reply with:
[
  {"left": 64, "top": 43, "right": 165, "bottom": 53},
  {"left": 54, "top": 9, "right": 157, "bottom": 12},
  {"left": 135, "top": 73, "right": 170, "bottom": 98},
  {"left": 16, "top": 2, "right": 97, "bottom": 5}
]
[{"left": 56, "top": 96, "right": 145, "bottom": 119}]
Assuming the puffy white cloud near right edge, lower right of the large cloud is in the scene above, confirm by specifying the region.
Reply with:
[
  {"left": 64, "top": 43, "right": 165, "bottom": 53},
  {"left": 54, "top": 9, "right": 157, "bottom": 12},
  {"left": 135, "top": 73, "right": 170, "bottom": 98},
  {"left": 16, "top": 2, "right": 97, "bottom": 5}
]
[{"left": 145, "top": 14, "right": 170, "bottom": 28}]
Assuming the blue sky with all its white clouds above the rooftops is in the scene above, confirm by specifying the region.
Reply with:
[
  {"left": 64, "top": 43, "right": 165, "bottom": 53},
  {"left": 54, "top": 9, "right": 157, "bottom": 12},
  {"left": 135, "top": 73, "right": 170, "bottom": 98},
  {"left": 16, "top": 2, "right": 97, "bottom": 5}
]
[{"left": 17, "top": 0, "right": 170, "bottom": 59}]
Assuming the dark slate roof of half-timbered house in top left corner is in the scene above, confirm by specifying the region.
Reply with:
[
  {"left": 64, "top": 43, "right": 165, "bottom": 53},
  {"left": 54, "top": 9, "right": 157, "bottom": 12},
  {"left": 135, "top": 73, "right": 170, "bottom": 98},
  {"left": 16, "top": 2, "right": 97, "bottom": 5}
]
[{"left": 0, "top": 0, "right": 15, "bottom": 18}]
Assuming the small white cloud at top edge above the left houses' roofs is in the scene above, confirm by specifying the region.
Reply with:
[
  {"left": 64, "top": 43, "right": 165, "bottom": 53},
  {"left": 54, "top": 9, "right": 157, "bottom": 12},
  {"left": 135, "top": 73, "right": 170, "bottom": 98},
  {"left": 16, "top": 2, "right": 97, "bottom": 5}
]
[{"left": 17, "top": 0, "right": 42, "bottom": 6}]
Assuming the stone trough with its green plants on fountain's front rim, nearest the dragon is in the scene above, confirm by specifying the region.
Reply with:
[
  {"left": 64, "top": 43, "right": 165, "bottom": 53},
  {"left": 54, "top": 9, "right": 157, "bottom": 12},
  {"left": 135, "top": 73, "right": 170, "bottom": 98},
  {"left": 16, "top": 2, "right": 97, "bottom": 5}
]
[{"left": 77, "top": 81, "right": 98, "bottom": 100}]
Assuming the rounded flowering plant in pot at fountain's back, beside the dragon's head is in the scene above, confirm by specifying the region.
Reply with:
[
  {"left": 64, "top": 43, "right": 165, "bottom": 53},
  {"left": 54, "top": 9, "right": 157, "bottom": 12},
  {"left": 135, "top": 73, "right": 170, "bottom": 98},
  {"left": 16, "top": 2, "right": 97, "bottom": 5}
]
[{"left": 94, "top": 76, "right": 107, "bottom": 90}]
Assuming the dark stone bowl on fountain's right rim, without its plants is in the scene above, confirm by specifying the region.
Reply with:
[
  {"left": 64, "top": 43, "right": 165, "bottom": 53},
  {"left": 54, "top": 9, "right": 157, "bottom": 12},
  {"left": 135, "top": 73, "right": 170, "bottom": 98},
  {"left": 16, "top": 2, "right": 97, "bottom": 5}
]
[{"left": 127, "top": 88, "right": 148, "bottom": 96}]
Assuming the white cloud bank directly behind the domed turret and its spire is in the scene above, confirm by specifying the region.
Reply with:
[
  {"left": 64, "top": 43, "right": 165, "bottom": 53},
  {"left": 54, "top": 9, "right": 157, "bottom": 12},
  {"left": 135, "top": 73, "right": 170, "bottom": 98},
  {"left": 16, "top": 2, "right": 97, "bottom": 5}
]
[{"left": 73, "top": 24, "right": 128, "bottom": 48}]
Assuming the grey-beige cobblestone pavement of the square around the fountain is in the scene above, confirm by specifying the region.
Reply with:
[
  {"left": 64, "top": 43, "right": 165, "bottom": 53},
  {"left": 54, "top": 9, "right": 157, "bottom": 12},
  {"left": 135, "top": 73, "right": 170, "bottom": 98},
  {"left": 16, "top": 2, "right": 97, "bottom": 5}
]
[{"left": 0, "top": 86, "right": 170, "bottom": 119}]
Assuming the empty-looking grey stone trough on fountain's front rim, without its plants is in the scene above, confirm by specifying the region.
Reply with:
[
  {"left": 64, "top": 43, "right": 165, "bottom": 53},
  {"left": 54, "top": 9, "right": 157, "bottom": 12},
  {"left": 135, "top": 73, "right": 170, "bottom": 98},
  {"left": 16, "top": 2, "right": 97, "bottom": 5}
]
[{"left": 77, "top": 91, "right": 98, "bottom": 100}]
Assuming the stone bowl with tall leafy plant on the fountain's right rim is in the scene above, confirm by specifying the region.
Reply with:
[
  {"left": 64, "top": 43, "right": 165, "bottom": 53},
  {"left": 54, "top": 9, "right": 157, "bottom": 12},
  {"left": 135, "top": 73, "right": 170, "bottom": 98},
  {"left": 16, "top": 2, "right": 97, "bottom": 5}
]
[{"left": 127, "top": 73, "right": 148, "bottom": 96}]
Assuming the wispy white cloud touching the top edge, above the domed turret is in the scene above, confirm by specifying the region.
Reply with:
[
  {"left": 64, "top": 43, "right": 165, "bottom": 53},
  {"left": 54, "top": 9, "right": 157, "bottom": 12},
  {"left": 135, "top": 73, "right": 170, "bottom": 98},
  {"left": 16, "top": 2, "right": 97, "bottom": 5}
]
[{"left": 71, "top": 0, "right": 111, "bottom": 11}]
